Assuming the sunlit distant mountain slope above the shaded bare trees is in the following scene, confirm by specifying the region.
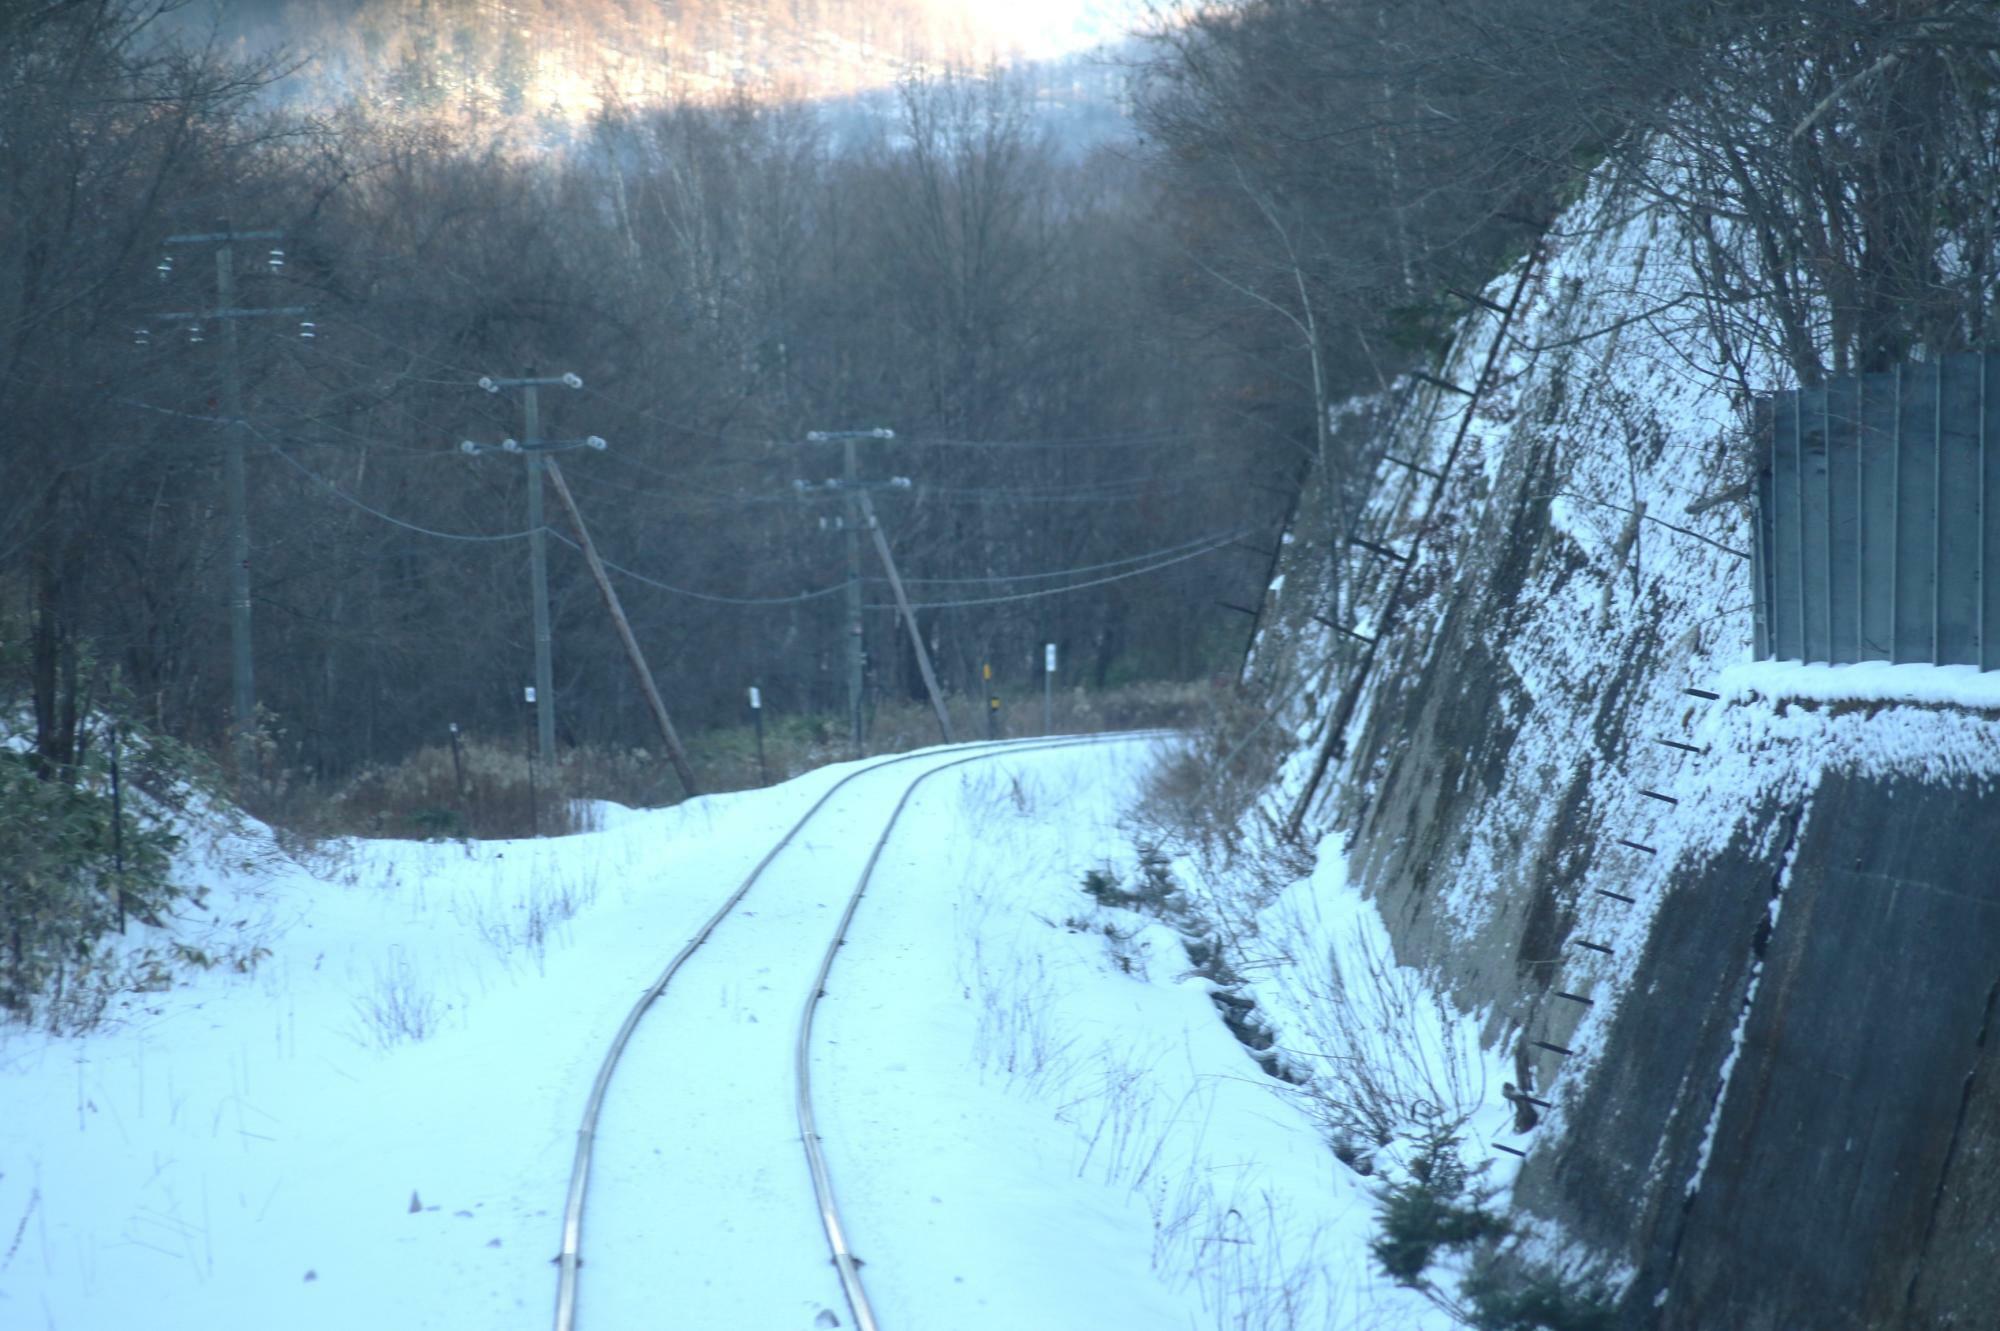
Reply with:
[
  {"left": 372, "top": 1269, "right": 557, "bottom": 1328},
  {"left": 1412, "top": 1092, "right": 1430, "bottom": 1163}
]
[{"left": 191, "top": 0, "right": 1122, "bottom": 128}]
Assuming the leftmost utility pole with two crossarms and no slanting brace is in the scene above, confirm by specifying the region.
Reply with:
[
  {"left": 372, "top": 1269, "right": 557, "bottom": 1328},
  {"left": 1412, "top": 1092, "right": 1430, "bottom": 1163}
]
[{"left": 156, "top": 218, "right": 310, "bottom": 777}]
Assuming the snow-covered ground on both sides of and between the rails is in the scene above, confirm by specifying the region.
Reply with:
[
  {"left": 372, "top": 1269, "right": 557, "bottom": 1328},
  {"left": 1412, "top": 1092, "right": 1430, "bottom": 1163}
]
[{"left": 0, "top": 741, "right": 1488, "bottom": 1331}]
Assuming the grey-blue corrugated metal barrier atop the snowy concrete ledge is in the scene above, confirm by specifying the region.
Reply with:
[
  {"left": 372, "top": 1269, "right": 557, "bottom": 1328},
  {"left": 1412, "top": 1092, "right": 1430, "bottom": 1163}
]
[{"left": 1752, "top": 352, "right": 2000, "bottom": 669}]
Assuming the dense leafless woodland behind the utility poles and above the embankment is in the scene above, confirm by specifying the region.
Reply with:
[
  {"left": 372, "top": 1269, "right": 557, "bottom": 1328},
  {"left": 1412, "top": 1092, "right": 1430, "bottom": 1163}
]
[{"left": 0, "top": 0, "right": 2000, "bottom": 807}]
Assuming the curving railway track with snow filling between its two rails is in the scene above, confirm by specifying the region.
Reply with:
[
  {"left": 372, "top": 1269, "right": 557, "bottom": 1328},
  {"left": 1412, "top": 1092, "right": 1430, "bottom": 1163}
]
[{"left": 556, "top": 731, "right": 1156, "bottom": 1331}]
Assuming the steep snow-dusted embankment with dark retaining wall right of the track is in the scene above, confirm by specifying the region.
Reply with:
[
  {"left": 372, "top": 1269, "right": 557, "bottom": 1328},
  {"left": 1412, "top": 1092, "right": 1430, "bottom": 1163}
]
[{"left": 1250, "top": 181, "right": 2000, "bottom": 1329}]
